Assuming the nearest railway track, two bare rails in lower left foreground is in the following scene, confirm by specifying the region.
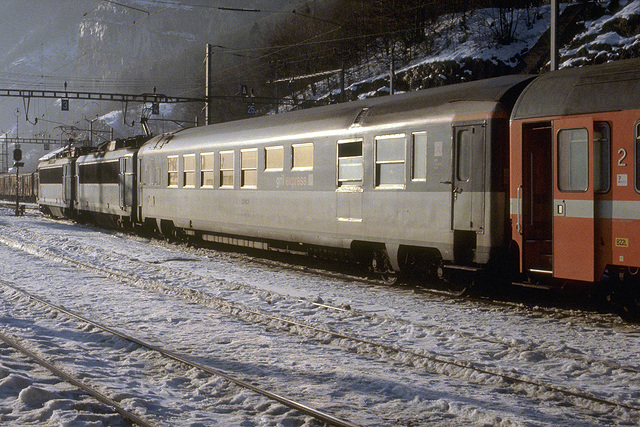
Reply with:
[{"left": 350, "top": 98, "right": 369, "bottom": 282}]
[{"left": 0, "top": 279, "right": 356, "bottom": 427}]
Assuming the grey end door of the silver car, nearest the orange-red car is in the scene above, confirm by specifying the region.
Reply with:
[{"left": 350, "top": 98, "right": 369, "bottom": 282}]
[{"left": 451, "top": 124, "right": 486, "bottom": 263}]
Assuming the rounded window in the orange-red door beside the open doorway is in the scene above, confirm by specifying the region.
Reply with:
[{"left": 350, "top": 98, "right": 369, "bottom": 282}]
[{"left": 558, "top": 128, "right": 589, "bottom": 192}]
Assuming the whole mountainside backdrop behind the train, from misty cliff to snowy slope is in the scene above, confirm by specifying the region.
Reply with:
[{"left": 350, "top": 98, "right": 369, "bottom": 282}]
[{"left": 0, "top": 0, "right": 640, "bottom": 172}]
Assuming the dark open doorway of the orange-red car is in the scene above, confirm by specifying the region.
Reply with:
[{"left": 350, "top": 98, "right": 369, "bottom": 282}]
[{"left": 517, "top": 122, "right": 553, "bottom": 277}]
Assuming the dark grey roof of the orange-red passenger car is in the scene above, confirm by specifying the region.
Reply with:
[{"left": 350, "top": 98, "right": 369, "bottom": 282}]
[{"left": 511, "top": 59, "right": 640, "bottom": 120}]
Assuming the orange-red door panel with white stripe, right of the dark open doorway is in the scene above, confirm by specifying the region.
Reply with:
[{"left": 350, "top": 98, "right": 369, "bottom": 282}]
[{"left": 553, "top": 118, "right": 595, "bottom": 282}]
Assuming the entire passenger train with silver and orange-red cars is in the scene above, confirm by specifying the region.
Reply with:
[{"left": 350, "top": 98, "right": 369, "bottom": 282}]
[{"left": 33, "top": 59, "right": 640, "bottom": 320}]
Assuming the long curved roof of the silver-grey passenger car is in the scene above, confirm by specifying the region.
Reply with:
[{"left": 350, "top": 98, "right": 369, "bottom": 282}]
[{"left": 143, "top": 75, "right": 533, "bottom": 151}]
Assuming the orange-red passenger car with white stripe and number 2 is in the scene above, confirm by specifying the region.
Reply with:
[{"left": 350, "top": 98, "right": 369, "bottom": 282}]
[{"left": 510, "top": 60, "right": 640, "bottom": 315}]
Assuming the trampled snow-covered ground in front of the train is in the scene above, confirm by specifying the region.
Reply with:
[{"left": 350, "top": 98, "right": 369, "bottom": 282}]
[{"left": 0, "top": 209, "right": 640, "bottom": 426}]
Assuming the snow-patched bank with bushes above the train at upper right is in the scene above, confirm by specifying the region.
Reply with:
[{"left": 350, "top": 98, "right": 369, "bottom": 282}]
[{"left": 298, "top": 0, "right": 640, "bottom": 105}]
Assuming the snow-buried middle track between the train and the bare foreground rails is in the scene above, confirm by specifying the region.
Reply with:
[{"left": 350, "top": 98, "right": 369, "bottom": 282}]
[{"left": 5, "top": 224, "right": 640, "bottom": 422}]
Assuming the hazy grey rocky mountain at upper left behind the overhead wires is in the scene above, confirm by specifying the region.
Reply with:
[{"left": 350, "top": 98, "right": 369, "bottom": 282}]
[{"left": 0, "top": 0, "right": 299, "bottom": 170}]
